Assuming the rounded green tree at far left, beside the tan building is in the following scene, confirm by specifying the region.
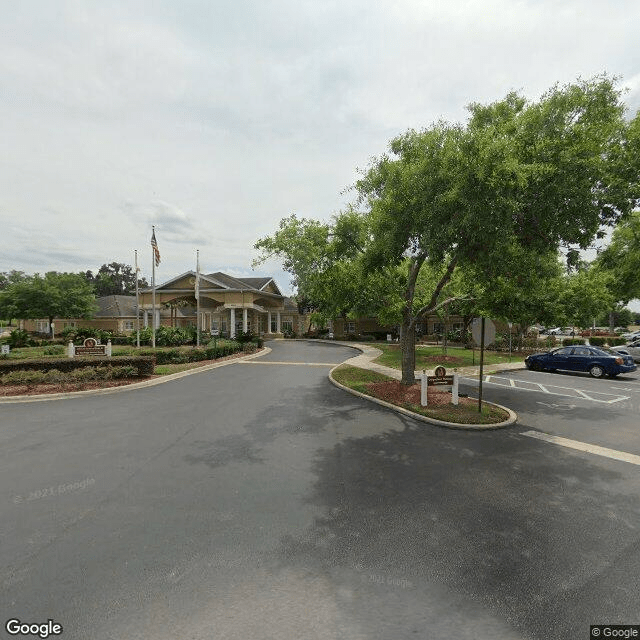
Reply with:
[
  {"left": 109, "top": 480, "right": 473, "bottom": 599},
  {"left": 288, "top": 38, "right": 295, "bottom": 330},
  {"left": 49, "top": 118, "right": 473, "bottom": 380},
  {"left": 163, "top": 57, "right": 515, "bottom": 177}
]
[{"left": 0, "top": 271, "right": 96, "bottom": 338}]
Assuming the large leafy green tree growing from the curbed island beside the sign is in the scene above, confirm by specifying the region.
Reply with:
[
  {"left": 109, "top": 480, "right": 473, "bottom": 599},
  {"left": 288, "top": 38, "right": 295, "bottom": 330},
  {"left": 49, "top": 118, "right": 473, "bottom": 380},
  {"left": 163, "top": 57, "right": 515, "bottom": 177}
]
[{"left": 356, "top": 78, "right": 638, "bottom": 384}]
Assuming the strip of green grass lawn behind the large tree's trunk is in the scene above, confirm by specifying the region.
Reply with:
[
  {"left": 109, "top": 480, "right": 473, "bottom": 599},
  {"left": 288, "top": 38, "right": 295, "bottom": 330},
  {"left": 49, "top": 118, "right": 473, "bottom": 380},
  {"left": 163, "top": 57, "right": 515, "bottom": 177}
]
[{"left": 374, "top": 344, "right": 524, "bottom": 371}]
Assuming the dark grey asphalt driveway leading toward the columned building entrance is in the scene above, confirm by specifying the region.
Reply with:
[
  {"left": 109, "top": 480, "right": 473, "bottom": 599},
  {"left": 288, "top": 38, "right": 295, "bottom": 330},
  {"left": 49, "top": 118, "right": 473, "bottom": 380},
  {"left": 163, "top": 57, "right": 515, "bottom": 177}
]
[{"left": 0, "top": 342, "right": 640, "bottom": 640}]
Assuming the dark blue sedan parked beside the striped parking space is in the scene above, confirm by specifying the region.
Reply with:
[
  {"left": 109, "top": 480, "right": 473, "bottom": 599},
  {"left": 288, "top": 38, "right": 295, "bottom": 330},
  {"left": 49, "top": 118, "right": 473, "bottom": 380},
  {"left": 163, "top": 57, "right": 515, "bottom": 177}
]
[{"left": 524, "top": 346, "right": 638, "bottom": 378}]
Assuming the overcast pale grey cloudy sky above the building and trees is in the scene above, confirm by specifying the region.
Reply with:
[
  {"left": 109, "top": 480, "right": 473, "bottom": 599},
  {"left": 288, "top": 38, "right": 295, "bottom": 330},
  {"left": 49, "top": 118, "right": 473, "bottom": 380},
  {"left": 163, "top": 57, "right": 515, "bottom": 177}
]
[{"left": 0, "top": 0, "right": 640, "bottom": 308}]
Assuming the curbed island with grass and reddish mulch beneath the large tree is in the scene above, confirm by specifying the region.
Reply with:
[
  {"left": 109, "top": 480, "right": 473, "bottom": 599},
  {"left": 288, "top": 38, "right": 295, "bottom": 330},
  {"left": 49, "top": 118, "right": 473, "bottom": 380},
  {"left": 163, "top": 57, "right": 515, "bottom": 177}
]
[{"left": 329, "top": 364, "right": 517, "bottom": 429}]
